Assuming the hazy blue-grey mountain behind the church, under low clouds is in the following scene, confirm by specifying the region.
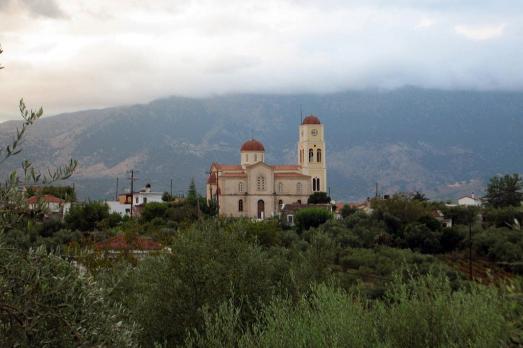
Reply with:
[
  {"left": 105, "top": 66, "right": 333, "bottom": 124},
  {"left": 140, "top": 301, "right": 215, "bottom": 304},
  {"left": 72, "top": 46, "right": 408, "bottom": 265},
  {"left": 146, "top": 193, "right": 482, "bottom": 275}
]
[{"left": 0, "top": 88, "right": 523, "bottom": 200}]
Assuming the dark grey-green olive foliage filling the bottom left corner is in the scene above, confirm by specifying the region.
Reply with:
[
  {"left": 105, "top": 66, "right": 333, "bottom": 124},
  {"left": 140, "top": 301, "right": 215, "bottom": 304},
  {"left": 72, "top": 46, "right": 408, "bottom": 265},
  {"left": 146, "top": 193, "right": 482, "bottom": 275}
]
[{"left": 0, "top": 241, "right": 138, "bottom": 347}]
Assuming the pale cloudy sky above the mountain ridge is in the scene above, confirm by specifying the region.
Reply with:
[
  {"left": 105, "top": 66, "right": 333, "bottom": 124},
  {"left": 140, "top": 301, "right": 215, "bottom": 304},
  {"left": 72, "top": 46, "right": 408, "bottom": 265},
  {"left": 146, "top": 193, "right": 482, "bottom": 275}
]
[{"left": 0, "top": 0, "right": 523, "bottom": 121}]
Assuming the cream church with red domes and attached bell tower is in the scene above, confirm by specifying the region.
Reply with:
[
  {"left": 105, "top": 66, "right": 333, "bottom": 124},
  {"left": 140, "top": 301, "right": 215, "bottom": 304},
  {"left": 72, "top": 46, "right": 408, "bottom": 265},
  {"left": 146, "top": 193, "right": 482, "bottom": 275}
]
[{"left": 207, "top": 115, "right": 327, "bottom": 219}]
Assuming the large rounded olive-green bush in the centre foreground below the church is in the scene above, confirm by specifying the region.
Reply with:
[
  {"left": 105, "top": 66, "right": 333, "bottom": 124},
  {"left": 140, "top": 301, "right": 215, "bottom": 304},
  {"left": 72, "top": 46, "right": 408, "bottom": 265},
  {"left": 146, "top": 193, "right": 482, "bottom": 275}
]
[{"left": 114, "top": 223, "right": 300, "bottom": 347}]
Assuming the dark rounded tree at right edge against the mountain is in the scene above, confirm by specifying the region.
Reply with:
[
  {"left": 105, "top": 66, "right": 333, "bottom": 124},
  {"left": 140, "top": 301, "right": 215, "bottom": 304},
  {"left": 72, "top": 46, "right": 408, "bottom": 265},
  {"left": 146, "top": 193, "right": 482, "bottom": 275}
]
[{"left": 485, "top": 174, "right": 523, "bottom": 208}]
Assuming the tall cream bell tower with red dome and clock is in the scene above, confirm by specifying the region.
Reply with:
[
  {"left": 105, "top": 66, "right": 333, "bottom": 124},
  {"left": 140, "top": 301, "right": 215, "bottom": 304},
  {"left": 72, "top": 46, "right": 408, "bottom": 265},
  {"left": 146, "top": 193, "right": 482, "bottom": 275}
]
[{"left": 298, "top": 115, "right": 328, "bottom": 192}]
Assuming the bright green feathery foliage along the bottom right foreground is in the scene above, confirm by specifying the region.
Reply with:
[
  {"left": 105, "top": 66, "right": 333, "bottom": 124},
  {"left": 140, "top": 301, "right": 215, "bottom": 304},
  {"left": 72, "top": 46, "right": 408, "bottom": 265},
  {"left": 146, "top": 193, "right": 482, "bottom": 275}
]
[{"left": 186, "top": 274, "right": 509, "bottom": 348}]
